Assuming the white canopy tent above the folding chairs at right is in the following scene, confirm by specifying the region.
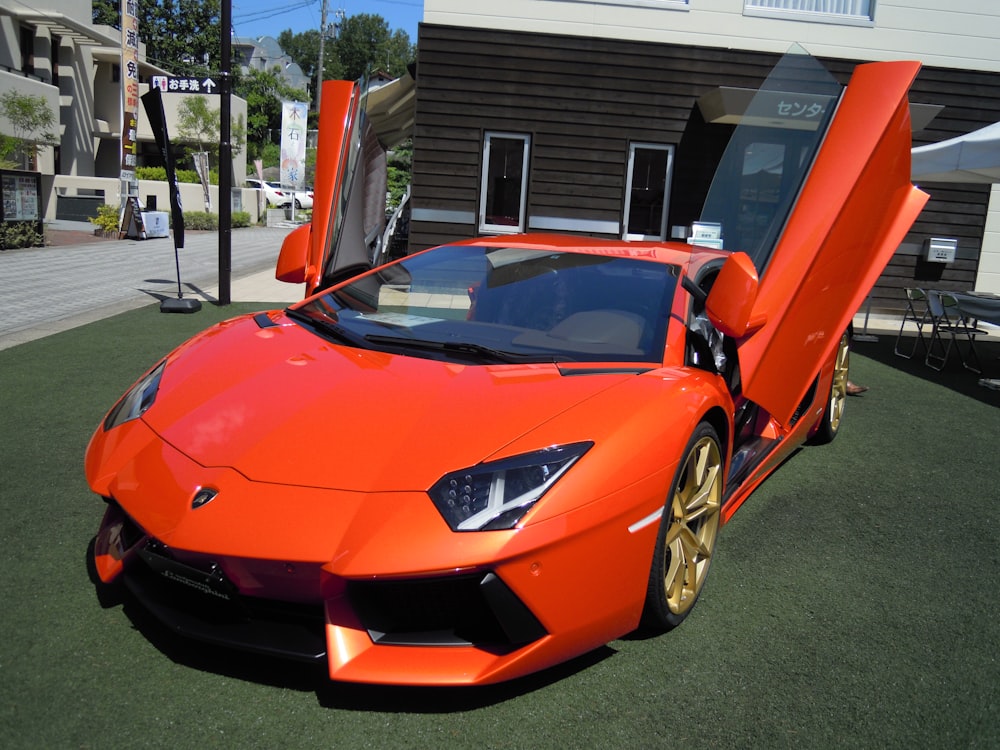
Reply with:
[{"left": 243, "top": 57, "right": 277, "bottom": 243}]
[{"left": 910, "top": 122, "right": 1000, "bottom": 184}]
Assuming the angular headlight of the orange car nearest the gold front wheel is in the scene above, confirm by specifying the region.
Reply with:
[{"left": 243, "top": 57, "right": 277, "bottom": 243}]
[{"left": 428, "top": 442, "right": 593, "bottom": 531}]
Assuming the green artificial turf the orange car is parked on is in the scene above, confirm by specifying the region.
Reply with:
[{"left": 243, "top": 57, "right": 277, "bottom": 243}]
[{"left": 0, "top": 305, "right": 1000, "bottom": 749}]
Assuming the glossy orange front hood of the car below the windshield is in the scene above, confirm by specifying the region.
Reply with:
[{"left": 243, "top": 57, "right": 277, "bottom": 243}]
[{"left": 143, "top": 313, "right": 635, "bottom": 492}]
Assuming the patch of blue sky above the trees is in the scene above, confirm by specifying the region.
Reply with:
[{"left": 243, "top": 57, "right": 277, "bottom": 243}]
[{"left": 232, "top": 0, "right": 424, "bottom": 44}]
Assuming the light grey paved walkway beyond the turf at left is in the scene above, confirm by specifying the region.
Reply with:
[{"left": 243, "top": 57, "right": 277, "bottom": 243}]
[{"left": 0, "top": 222, "right": 304, "bottom": 349}]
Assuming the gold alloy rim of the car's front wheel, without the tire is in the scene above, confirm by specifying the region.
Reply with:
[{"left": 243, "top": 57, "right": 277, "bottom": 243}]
[{"left": 663, "top": 435, "right": 722, "bottom": 615}]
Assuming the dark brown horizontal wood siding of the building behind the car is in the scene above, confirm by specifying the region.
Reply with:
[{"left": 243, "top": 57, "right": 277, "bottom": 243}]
[{"left": 410, "top": 24, "right": 1000, "bottom": 309}]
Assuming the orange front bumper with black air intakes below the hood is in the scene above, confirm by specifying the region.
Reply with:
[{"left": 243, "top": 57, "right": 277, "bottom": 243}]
[{"left": 88, "top": 423, "right": 665, "bottom": 685}]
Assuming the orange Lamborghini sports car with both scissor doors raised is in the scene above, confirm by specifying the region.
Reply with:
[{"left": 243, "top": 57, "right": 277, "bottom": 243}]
[{"left": 86, "top": 57, "right": 926, "bottom": 685}]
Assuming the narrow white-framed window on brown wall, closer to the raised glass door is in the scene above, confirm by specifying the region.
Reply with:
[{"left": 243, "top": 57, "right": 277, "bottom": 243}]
[{"left": 622, "top": 143, "right": 674, "bottom": 240}]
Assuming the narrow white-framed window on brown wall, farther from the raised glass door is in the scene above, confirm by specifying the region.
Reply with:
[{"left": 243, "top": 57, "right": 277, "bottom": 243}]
[{"left": 479, "top": 133, "right": 531, "bottom": 233}]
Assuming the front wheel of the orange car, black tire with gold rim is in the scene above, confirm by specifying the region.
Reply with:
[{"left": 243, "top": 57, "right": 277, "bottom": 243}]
[{"left": 642, "top": 422, "right": 725, "bottom": 631}]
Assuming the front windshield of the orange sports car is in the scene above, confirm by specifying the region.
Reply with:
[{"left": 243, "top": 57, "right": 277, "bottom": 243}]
[{"left": 290, "top": 245, "right": 678, "bottom": 364}]
